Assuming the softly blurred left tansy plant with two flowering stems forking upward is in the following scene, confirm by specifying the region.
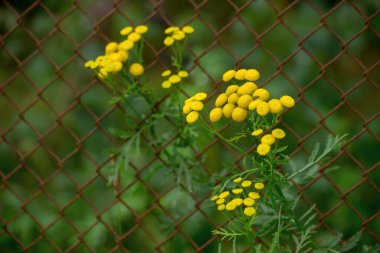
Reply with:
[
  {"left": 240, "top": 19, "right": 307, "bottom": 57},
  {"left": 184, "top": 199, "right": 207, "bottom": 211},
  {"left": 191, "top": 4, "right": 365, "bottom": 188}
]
[{"left": 85, "top": 25, "right": 203, "bottom": 190}]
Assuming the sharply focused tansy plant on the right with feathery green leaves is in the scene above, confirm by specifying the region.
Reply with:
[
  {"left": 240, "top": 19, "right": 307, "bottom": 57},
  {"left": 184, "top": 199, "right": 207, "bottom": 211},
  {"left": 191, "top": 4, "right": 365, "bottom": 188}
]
[{"left": 182, "top": 69, "right": 348, "bottom": 252}]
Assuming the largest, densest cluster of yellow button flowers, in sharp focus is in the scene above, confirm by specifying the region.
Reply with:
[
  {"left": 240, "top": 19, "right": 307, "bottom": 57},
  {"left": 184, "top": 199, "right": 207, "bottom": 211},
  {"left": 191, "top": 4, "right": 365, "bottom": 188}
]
[{"left": 210, "top": 69, "right": 295, "bottom": 122}]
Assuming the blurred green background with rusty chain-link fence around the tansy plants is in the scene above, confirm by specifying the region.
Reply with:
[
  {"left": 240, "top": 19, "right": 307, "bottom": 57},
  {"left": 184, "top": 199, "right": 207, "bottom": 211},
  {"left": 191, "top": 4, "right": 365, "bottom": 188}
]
[{"left": 0, "top": 0, "right": 380, "bottom": 252}]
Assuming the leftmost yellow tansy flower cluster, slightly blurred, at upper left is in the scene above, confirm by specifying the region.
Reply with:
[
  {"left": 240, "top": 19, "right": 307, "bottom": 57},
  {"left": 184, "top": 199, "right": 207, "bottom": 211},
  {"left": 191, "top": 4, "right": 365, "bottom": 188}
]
[{"left": 84, "top": 25, "right": 148, "bottom": 79}]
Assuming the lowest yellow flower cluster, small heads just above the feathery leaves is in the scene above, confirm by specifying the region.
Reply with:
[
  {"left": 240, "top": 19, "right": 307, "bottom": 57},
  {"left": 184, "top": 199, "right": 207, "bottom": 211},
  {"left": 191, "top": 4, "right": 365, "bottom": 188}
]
[{"left": 211, "top": 177, "right": 264, "bottom": 217}]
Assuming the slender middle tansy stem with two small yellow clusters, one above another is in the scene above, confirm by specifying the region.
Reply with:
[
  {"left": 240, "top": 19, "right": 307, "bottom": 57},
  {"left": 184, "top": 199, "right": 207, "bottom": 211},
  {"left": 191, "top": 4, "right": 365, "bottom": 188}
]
[{"left": 153, "top": 26, "right": 207, "bottom": 191}]
